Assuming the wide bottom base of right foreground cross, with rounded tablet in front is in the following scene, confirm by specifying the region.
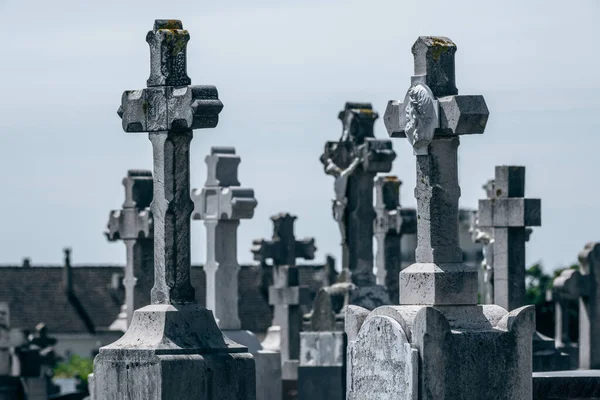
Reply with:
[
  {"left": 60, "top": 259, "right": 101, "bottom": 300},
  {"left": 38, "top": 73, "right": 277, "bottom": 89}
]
[{"left": 346, "top": 304, "right": 535, "bottom": 400}]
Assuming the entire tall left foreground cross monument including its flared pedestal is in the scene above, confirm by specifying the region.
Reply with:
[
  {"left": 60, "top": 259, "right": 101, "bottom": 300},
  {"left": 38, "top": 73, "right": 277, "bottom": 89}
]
[{"left": 92, "top": 20, "right": 256, "bottom": 400}]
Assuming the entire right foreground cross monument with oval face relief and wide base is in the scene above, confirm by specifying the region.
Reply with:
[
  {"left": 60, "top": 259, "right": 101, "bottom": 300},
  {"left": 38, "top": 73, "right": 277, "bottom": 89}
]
[{"left": 345, "top": 36, "right": 534, "bottom": 400}]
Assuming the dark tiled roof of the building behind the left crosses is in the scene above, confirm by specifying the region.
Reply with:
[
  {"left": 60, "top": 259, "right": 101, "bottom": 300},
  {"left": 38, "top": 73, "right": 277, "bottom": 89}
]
[{"left": 0, "top": 264, "right": 326, "bottom": 333}]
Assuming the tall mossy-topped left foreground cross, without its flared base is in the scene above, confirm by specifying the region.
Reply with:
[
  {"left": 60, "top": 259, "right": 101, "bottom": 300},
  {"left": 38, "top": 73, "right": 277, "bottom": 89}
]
[{"left": 118, "top": 20, "right": 223, "bottom": 304}]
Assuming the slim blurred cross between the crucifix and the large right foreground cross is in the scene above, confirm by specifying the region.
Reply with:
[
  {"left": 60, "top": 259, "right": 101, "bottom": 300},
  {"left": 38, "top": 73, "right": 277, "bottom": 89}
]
[{"left": 373, "top": 176, "right": 417, "bottom": 304}]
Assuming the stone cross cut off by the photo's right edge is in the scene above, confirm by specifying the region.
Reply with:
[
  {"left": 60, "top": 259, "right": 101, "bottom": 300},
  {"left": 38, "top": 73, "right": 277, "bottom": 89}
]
[{"left": 554, "top": 242, "right": 600, "bottom": 369}]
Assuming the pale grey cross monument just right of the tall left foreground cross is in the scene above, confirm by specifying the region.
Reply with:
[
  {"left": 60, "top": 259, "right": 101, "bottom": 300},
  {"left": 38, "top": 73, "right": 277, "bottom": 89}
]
[{"left": 192, "top": 147, "right": 281, "bottom": 400}]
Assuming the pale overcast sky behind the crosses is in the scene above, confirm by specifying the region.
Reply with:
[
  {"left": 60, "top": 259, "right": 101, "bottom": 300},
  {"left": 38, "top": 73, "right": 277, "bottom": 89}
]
[{"left": 0, "top": 0, "right": 600, "bottom": 269}]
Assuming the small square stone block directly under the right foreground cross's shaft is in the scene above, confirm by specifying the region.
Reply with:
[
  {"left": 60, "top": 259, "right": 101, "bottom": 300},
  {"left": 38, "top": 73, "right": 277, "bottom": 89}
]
[{"left": 399, "top": 263, "right": 478, "bottom": 305}]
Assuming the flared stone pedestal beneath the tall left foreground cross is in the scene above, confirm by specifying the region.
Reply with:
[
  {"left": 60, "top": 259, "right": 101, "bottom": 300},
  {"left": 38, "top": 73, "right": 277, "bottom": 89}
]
[{"left": 93, "top": 305, "right": 256, "bottom": 400}]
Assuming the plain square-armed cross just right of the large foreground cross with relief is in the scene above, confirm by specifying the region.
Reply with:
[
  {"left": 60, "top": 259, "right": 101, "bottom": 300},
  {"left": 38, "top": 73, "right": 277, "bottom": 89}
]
[{"left": 478, "top": 165, "right": 541, "bottom": 310}]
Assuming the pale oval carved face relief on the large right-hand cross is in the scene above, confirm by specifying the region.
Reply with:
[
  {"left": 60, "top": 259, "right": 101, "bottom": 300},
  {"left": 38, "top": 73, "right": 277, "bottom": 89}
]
[{"left": 400, "top": 81, "right": 439, "bottom": 155}]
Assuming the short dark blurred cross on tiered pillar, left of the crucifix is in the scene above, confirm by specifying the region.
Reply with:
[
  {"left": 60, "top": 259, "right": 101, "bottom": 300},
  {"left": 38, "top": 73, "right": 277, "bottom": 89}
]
[{"left": 252, "top": 213, "right": 316, "bottom": 399}]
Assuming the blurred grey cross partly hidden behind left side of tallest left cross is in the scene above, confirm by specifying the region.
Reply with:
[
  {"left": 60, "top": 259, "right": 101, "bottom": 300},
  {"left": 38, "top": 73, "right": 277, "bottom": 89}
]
[{"left": 104, "top": 170, "right": 154, "bottom": 330}]
